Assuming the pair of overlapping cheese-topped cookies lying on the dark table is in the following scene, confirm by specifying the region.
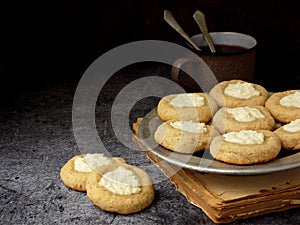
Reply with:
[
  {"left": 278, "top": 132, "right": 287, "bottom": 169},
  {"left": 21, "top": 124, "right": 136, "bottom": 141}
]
[{"left": 60, "top": 153, "right": 154, "bottom": 214}]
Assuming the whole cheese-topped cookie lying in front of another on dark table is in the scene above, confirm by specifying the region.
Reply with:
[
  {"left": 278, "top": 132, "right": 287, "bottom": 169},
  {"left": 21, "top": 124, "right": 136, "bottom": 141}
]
[{"left": 87, "top": 164, "right": 154, "bottom": 214}]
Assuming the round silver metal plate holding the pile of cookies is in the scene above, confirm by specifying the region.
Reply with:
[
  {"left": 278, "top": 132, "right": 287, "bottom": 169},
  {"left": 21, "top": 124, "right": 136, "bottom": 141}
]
[{"left": 138, "top": 108, "right": 300, "bottom": 175}]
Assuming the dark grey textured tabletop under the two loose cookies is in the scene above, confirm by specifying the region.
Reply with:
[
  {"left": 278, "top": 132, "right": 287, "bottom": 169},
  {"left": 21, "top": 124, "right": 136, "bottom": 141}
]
[{"left": 0, "top": 63, "right": 300, "bottom": 225}]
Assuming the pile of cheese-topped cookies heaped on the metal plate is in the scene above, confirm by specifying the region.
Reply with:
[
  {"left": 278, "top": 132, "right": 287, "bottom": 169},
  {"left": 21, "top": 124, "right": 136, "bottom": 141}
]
[{"left": 154, "top": 80, "right": 300, "bottom": 165}]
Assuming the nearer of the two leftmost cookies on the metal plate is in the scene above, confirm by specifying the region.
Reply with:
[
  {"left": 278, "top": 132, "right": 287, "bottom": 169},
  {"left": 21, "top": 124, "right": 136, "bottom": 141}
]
[{"left": 154, "top": 121, "right": 218, "bottom": 154}]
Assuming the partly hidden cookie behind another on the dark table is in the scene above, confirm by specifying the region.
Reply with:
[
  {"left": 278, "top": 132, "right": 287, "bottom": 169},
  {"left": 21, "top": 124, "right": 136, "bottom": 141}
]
[{"left": 60, "top": 153, "right": 126, "bottom": 191}]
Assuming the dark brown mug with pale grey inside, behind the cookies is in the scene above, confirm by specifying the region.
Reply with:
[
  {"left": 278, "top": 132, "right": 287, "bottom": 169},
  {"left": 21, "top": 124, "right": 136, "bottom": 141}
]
[{"left": 171, "top": 32, "right": 257, "bottom": 90}]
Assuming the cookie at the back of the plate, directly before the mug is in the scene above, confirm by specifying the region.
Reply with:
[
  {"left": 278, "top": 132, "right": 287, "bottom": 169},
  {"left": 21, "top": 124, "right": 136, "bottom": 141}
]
[{"left": 209, "top": 80, "right": 269, "bottom": 107}]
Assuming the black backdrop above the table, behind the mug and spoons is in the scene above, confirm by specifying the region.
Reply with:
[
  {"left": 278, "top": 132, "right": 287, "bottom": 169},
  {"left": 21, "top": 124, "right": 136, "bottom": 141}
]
[{"left": 0, "top": 0, "right": 300, "bottom": 95}]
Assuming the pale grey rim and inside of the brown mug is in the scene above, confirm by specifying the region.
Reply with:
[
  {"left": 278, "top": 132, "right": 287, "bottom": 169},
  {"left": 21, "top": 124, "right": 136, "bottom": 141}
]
[{"left": 191, "top": 31, "right": 257, "bottom": 55}]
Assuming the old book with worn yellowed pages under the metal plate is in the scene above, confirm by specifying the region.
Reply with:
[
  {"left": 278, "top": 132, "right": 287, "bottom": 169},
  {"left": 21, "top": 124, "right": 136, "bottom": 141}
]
[{"left": 133, "top": 120, "right": 300, "bottom": 223}]
